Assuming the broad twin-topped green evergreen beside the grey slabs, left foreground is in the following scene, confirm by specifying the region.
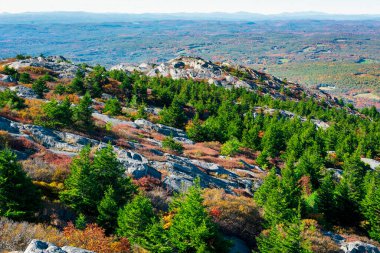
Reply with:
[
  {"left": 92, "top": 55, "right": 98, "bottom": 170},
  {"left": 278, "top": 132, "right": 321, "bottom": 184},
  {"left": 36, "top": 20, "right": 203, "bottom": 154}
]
[{"left": 60, "top": 144, "right": 136, "bottom": 217}]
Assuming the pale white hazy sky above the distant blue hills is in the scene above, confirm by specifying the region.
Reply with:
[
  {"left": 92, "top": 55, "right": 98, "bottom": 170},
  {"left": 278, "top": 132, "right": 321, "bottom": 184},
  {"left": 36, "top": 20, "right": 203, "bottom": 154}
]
[{"left": 0, "top": 0, "right": 380, "bottom": 14}]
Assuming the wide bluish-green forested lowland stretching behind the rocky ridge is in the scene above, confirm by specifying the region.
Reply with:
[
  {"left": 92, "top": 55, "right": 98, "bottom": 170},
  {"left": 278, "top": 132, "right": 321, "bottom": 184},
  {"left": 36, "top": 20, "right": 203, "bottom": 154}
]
[{"left": 0, "top": 20, "right": 380, "bottom": 107}]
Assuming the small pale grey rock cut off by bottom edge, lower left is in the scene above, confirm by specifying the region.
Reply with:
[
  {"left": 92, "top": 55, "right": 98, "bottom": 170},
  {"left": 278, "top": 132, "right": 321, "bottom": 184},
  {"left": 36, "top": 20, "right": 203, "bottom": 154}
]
[{"left": 24, "top": 240, "right": 94, "bottom": 253}]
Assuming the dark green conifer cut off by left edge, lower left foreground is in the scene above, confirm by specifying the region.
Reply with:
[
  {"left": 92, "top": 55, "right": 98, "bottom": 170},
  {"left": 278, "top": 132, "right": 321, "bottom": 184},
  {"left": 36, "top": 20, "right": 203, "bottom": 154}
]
[{"left": 0, "top": 149, "right": 41, "bottom": 220}]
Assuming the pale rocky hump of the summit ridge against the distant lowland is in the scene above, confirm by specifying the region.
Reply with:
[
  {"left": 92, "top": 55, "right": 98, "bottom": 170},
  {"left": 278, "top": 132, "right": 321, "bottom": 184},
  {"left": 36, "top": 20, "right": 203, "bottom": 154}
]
[{"left": 111, "top": 56, "right": 337, "bottom": 110}]
